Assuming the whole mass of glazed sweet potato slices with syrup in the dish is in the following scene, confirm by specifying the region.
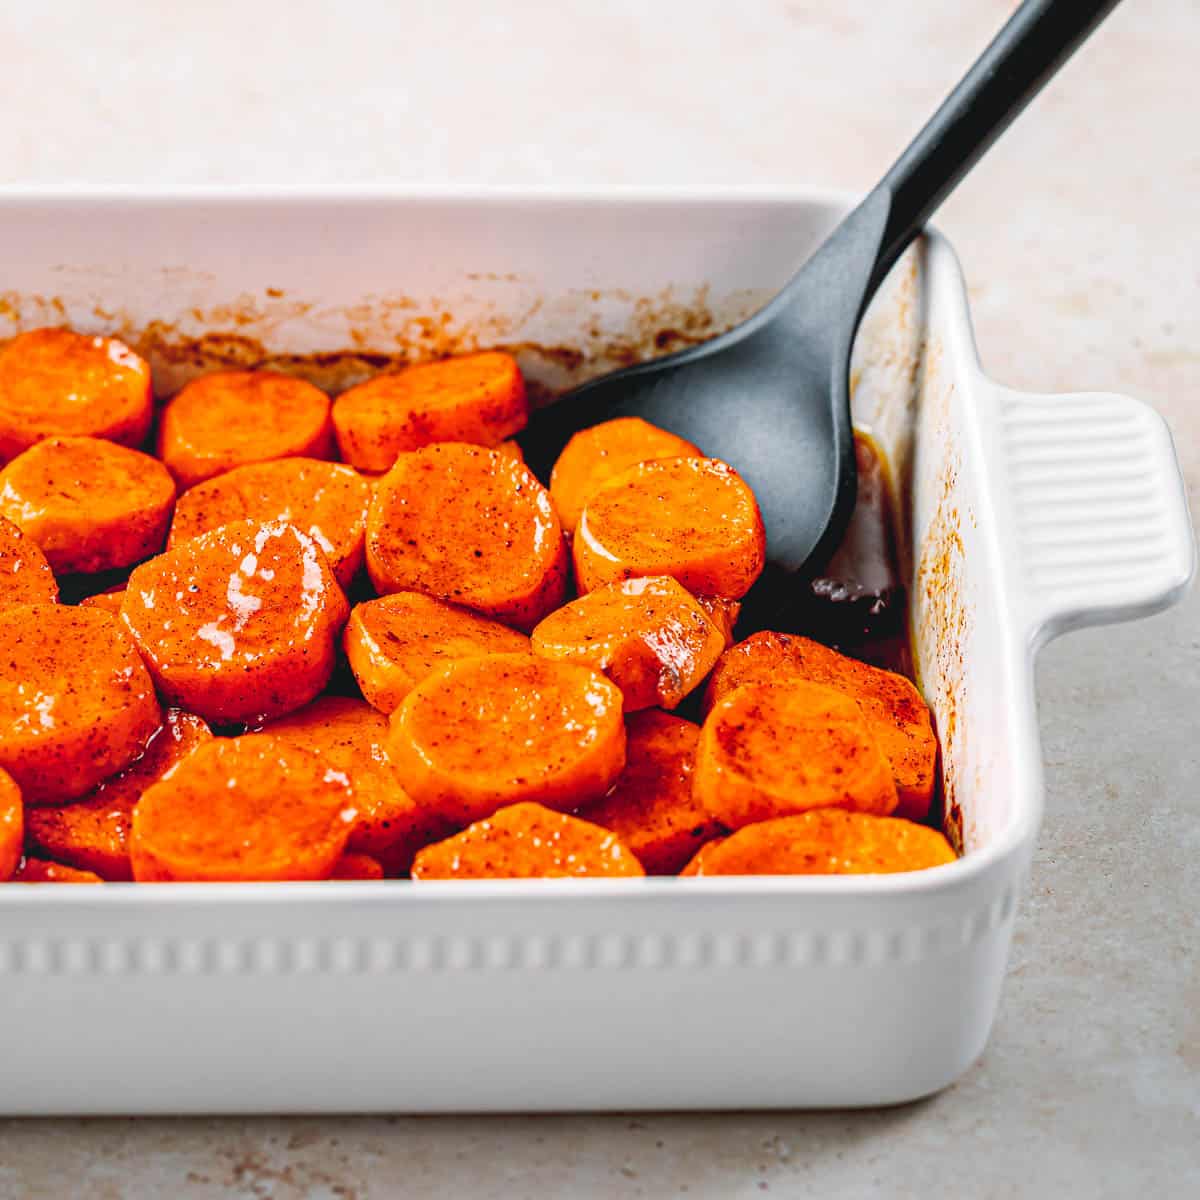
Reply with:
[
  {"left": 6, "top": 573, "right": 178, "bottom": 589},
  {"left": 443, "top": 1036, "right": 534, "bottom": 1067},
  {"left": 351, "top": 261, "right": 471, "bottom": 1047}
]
[{"left": 0, "top": 330, "right": 954, "bottom": 886}]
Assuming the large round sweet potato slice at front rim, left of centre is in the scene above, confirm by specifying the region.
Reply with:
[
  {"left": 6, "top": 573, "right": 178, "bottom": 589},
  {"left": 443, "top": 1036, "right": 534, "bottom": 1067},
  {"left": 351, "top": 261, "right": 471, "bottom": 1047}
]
[{"left": 130, "top": 733, "right": 355, "bottom": 883}]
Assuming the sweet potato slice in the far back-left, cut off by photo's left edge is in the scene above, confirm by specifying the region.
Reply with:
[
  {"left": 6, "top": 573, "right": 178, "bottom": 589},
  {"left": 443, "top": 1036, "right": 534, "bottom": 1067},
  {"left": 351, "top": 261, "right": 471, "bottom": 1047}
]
[{"left": 0, "top": 329, "right": 154, "bottom": 462}]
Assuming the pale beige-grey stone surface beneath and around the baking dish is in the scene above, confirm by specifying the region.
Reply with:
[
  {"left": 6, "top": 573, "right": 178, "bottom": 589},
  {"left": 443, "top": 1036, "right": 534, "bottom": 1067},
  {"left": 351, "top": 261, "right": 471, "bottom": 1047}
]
[{"left": 0, "top": 0, "right": 1200, "bottom": 1200}]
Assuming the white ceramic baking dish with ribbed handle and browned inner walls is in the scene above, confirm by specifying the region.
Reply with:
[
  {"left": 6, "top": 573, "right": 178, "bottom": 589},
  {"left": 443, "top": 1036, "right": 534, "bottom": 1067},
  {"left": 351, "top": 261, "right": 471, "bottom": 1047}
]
[{"left": 0, "top": 192, "right": 1193, "bottom": 1114}]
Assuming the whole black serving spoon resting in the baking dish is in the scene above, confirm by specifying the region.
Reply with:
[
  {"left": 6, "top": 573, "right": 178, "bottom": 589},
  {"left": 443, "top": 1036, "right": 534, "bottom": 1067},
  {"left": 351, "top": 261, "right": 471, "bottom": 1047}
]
[{"left": 522, "top": 0, "right": 1117, "bottom": 624}]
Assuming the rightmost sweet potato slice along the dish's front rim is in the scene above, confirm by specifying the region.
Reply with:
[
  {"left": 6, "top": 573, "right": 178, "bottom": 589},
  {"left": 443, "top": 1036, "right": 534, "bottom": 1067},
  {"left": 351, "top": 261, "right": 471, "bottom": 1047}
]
[{"left": 691, "top": 809, "right": 955, "bottom": 875}]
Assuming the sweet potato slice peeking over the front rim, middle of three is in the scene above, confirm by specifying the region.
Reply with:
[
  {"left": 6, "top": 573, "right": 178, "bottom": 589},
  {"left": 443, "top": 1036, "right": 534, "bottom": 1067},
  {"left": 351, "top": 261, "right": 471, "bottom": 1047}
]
[{"left": 413, "top": 803, "right": 646, "bottom": 880}]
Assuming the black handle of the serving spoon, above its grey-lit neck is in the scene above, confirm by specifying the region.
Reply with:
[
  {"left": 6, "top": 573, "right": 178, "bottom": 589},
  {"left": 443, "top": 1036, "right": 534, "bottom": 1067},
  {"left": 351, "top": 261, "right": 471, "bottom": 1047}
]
[{"left": 872, "top": 0, "right": 1117, "bottom": 283}]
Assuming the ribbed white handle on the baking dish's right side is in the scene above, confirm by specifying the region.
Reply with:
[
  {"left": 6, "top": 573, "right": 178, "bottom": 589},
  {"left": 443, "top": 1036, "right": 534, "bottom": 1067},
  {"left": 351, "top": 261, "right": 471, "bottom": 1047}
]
[{"left": 992, "top": 389, "right": 1195, "bottom": 644}]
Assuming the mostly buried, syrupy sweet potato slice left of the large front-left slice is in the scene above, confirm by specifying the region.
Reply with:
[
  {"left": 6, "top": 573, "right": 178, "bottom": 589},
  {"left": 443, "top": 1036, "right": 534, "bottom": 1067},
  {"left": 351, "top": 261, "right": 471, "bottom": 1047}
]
[{"left": 26, "top": 708, "right": 212, "bottom": 881}]
